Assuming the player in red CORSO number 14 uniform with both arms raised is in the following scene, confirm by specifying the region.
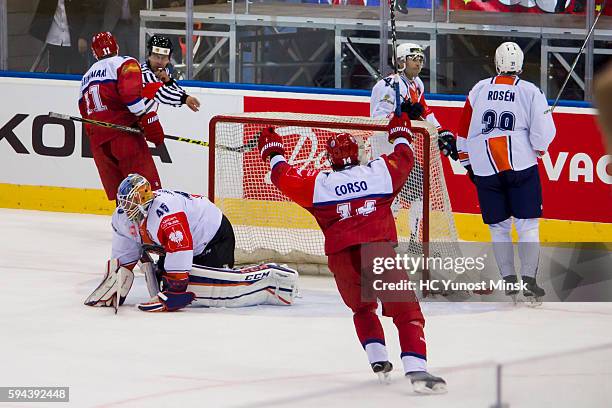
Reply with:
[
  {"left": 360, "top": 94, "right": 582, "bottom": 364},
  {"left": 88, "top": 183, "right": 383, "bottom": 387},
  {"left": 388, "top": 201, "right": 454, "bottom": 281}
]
[{"left": 258, "top": 114, "right": 446, "bottom": 393}]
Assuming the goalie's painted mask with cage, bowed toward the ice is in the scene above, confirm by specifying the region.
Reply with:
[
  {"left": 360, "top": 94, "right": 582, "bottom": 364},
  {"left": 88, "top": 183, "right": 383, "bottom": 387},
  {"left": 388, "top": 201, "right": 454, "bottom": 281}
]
[{"left": 117, "top": 173, "right": 155, "bottom": 223}]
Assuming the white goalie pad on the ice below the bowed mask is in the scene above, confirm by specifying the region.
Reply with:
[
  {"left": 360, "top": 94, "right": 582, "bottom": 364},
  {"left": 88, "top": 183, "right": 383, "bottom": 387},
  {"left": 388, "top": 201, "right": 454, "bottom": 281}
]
[{"left": 85, "top": 259, "right": 134, "bottom": 307}]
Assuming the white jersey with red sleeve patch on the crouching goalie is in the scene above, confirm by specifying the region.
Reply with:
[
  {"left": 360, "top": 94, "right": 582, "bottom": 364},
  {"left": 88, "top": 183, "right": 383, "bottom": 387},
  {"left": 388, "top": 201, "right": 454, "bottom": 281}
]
[{"left": 111, "top": 190, "right": 223, "bottom": 272}]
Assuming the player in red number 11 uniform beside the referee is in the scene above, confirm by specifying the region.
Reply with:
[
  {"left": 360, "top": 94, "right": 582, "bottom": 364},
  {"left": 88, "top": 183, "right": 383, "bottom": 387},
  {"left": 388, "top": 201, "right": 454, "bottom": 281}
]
[{"left": 79, "top": 32, "right": 164, "bottom": 200}]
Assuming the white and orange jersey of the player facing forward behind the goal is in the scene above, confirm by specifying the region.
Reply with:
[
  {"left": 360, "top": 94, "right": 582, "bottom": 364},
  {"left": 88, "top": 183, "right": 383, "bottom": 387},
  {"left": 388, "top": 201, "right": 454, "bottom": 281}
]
[{"left": 370, "top": 75, "right": 440, "bottom": 128}]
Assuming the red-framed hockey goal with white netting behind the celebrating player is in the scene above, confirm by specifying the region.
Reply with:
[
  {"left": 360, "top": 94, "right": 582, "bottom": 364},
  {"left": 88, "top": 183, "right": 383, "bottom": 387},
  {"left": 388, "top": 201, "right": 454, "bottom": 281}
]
[{"left": 209, "top": 112, "right": 457, "bottom": 264}]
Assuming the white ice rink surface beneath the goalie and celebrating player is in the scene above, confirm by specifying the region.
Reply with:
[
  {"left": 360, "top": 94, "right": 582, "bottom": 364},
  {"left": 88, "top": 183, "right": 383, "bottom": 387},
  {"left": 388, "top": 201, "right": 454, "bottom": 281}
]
[{"left": 0, "top": 209, "right": 612, "bottom": 408}]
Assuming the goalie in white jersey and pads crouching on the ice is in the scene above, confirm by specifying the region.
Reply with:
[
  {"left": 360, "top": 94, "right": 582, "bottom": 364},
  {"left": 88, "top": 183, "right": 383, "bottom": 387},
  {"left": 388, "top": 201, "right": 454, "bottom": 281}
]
[{"left": 85, "top": 174, "right": 297, "bottom": 312}]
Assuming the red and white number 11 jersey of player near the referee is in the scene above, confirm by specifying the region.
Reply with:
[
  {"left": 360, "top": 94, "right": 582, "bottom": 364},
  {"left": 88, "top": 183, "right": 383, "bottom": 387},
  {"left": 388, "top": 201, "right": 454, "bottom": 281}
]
[{"left": 79, "top": 56, "right": 145, "bottom": 145}]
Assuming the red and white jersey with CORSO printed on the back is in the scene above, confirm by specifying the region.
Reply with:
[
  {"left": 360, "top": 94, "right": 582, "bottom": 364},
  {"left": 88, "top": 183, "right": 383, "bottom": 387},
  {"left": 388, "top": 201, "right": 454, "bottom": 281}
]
[{"left": 270, "top": 138, "right": 414, "bottom": 255}]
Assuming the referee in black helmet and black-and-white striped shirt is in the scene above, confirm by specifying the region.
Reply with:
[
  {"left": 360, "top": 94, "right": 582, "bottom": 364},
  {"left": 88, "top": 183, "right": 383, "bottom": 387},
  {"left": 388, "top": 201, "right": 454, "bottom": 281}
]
[{"left": 141, "top": 34, "right": 200, "bottom": 112}]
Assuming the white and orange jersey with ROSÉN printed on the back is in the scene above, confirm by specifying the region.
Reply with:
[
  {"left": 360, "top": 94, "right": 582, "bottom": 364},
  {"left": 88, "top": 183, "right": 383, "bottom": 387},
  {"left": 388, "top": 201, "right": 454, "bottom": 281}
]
[{"left": 457, "top": 75, "right": 556, "bottom": 176}]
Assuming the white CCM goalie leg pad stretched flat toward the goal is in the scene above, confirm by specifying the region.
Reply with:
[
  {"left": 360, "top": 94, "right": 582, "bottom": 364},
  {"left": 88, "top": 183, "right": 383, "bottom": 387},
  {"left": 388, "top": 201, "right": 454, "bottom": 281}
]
[{"left": 189, "top": 263, "right": 298, "bottom": 307}]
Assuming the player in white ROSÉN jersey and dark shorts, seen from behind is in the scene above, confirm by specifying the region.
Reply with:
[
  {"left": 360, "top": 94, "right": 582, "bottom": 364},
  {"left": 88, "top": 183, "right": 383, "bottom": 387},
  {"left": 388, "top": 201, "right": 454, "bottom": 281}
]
[{"left": 457, "top": 42, "right": 556, "bottom": 298}]
